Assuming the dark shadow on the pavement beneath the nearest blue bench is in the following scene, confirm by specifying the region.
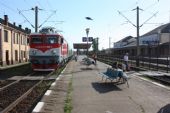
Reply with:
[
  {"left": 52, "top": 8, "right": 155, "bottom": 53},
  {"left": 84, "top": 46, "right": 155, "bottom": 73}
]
[{"left": 92, "top": 82, "right": 122, "bottom": 93}]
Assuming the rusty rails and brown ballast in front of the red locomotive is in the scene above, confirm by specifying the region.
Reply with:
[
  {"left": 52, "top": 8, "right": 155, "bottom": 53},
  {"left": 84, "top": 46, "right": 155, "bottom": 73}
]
[{"left": 0, "top": 72, "right": 54, "bottom": 113}]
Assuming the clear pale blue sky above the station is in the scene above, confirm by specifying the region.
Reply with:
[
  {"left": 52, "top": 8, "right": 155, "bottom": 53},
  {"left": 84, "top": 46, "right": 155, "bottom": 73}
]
[{"left": 0, "top": 0, "right": 170, "bottom": 50}]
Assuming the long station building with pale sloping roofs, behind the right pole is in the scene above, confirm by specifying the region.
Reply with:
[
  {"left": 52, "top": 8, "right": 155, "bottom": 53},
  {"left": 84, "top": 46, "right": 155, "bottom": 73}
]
[{"left": 112, "top": 23, "right": 170, "bottom": 57}]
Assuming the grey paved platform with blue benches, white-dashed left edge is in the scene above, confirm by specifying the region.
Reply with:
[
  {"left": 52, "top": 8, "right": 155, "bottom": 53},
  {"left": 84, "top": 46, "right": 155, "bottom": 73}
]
[{"left": 32, "top": 56, "right": 170, "bottom": 113}]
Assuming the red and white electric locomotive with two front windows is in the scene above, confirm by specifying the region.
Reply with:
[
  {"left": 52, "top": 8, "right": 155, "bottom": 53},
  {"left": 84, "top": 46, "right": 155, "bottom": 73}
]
[{"left": 29, "top": 27, "right": 71, "bottom": 71}]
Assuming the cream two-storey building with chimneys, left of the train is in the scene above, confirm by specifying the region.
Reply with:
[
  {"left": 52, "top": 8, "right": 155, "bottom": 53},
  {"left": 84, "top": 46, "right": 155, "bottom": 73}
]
[{"left": 0, "top": 15, "right": 31, "bottom": 66}]
